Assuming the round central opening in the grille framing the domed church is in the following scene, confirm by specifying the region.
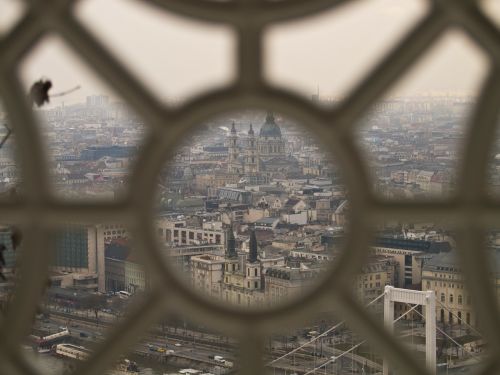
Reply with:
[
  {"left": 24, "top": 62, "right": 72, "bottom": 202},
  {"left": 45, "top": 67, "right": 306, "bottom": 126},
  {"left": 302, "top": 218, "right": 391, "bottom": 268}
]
[{"left": 156, "top": 110, "right": 349, "bottom": 310}]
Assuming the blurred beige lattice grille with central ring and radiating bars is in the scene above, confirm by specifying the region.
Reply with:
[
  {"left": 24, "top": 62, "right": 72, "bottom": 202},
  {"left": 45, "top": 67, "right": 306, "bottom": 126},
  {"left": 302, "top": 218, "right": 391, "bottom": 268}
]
[{"left": 0, "top": 0, "right": 500, "bottom": 375}]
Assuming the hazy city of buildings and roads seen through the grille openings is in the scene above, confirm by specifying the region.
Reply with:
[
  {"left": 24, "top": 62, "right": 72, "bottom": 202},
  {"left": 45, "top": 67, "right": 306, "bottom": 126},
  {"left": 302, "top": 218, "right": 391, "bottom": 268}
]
[{"left": 0, "top": 94, "right": 500, "bottom": 375}]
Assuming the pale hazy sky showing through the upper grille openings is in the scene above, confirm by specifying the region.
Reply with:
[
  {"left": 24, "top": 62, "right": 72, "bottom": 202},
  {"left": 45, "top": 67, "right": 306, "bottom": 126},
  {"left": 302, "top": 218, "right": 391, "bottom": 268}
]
[{"left": 0, "top": 0, "right": 500, "bottom": 103}]
